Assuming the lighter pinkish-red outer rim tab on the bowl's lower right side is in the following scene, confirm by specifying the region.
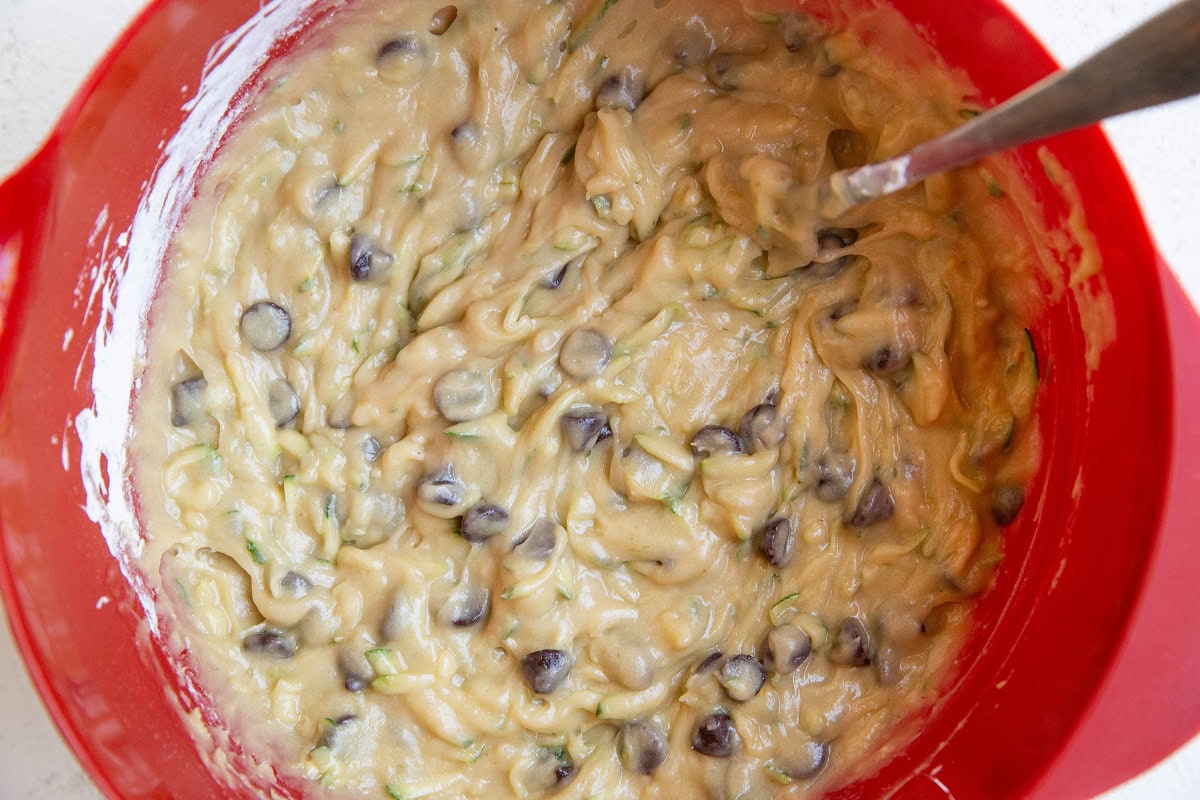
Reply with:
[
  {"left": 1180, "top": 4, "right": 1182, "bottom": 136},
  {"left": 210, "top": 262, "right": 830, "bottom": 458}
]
[{"left": 1030, "top": 261, "right": 1200, "bottom": 800}]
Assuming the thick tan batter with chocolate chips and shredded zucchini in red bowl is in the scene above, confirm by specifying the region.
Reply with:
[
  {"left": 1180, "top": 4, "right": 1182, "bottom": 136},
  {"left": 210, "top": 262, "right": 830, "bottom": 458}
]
[{"left": 133, "top": 0, "right": 1039, "bottom": 800}]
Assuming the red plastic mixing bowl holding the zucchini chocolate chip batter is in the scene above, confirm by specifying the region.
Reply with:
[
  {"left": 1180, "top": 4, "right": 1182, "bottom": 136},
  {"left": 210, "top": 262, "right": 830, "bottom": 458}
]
[{"left": 0, "top": 0, "right": 1200, "bottom": 800}]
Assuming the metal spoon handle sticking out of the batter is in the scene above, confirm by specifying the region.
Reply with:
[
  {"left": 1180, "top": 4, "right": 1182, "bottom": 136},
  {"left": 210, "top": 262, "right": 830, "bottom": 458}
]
[{"left": 816, "top": 0, "right": 1200, "bottom": 219}]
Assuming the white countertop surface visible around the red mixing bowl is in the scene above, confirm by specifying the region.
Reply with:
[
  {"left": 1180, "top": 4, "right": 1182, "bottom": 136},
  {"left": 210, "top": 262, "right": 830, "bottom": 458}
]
[{"left": 0, "top": 0, "right": 1200, "bottom": 800}]
